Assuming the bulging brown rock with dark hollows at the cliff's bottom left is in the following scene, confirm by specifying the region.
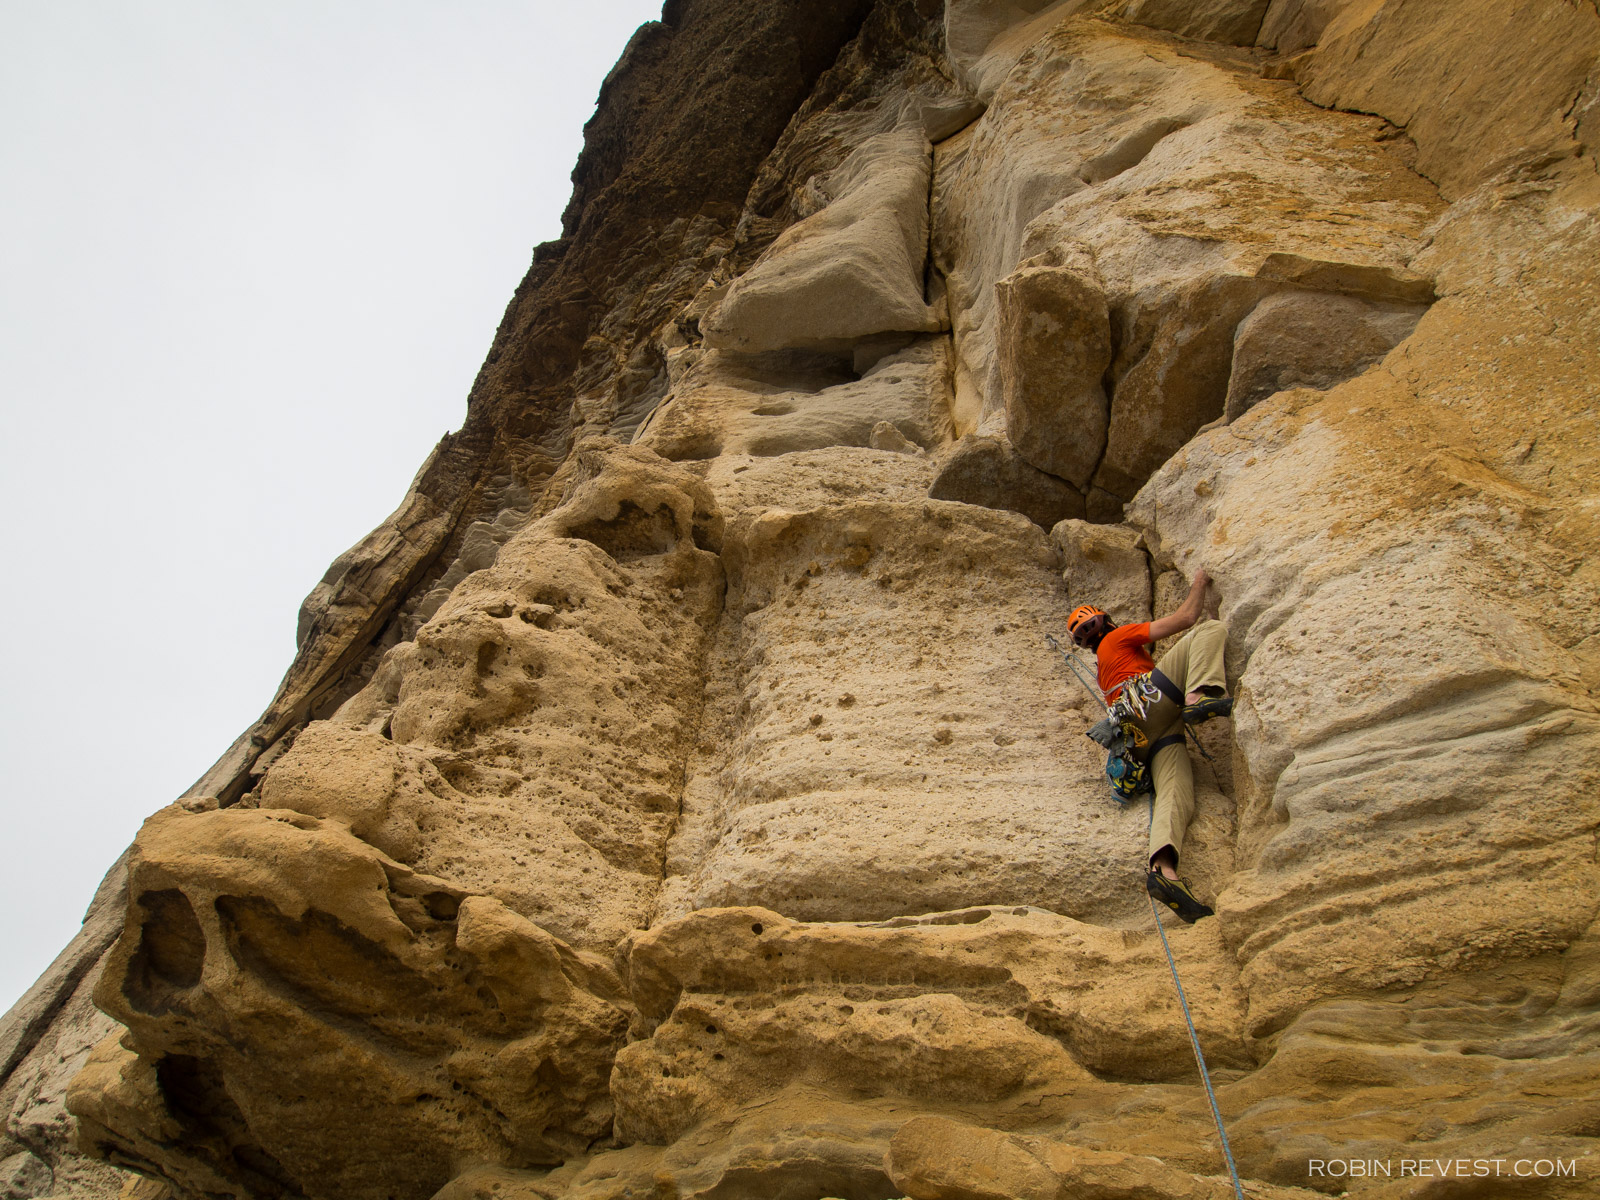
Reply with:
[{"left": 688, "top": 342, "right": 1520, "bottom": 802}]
[{"left": 69, "top": 810, "right": 626, "bottom": 1197}]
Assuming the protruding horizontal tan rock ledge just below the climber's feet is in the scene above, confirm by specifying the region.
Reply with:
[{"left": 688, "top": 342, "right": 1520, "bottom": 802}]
[{"left": 611, "top": 907, "right": 1248, "bottom": 1142}]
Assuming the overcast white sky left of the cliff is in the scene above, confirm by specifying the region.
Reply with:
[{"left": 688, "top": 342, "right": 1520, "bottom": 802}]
[{"left": 0, "top": 0, "right": 661, "bottom": 1010}]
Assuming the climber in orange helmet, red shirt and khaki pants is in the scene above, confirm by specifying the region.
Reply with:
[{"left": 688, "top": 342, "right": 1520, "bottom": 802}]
[{"left": 1067, "top": 570, "right": 1234, "bottom": 925}]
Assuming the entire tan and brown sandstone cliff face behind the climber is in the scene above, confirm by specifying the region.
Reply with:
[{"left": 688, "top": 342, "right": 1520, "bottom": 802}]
[{"left": 0, "top": 0, "right": 1600, "bottom": 1200}]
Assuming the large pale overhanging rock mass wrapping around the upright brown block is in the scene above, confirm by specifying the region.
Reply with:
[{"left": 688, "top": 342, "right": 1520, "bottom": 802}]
[{"left": 934, "top": 19, "right": 1438, "bottom": 499}]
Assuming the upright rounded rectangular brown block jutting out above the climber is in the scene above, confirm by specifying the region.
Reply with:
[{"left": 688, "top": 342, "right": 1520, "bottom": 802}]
[{"left": 995, "top": 267, "right": 1110, "bottom": 490}]
